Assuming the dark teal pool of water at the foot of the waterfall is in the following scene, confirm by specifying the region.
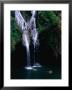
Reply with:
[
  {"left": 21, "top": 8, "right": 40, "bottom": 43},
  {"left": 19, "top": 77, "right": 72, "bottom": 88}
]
[{"left": 11, "top": 66, "right": 61, "bottom": 79}]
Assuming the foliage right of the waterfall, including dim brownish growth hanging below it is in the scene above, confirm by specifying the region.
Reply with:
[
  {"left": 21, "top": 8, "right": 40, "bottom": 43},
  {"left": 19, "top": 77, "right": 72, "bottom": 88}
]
[{"left": 38, "top": 11, "right": 61, "bottom": 54}]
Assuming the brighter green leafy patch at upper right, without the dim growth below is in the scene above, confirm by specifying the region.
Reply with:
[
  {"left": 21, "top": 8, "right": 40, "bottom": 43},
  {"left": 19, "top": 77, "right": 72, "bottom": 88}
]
[{"left": 38, "top": 11, "right": 60, "bottom": 31}]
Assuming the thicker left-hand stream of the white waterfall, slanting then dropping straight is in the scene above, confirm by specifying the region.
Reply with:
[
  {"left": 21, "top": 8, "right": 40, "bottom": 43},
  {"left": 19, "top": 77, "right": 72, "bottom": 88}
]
[{"left": 15, "top": 10, "right": 32, "bottom": 69}]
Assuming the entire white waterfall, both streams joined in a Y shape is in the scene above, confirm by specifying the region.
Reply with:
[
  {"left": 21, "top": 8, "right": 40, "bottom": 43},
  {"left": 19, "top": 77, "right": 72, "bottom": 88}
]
[{"left": 15, "top": 10, "right": 41, "bottom": 69}]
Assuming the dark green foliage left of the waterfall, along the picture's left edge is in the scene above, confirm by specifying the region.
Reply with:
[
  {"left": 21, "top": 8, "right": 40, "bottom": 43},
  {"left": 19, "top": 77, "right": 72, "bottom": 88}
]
[{"left": 11, "top": 17, "right": 21, "bottom": 50}]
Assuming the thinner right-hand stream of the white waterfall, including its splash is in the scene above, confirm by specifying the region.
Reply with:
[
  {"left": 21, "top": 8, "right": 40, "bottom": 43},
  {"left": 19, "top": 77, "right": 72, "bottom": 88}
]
[{"left": 30, "top": 10, "right": 41, "bottom": 67}]
